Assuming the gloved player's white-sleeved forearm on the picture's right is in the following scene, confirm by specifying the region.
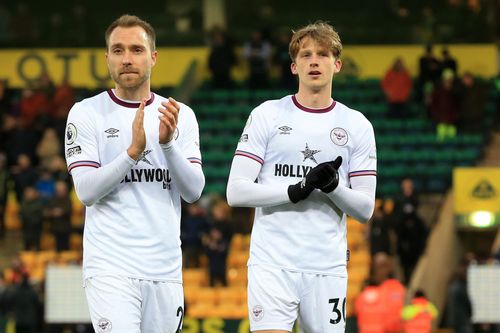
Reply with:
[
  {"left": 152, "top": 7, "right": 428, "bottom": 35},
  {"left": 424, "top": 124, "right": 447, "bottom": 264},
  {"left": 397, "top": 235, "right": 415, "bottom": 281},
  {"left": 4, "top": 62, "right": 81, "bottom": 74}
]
[{"left": 327, "top": 176, "right": 376, "bottom": 223}]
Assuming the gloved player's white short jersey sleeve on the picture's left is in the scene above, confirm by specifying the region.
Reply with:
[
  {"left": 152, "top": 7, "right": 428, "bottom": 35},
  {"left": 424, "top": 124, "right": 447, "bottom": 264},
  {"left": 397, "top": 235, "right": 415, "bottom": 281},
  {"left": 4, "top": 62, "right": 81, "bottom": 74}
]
[{"left": 235, "top": 107, "right": 269, "bottom": 164}]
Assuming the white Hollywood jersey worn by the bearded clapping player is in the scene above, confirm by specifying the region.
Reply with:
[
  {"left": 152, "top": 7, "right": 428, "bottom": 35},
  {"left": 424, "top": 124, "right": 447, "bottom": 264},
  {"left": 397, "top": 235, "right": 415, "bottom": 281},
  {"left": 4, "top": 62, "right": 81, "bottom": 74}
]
[{"left": 65, "top": 90, "right": 201, "bottom": 282}]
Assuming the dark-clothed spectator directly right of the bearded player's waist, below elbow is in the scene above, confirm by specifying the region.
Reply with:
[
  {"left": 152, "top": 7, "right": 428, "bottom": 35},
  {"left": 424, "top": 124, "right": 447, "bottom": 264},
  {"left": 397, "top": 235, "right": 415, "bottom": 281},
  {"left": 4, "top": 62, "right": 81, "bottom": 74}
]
[{"left": 181, "top": 202, "right": 209, "bottom": 268}]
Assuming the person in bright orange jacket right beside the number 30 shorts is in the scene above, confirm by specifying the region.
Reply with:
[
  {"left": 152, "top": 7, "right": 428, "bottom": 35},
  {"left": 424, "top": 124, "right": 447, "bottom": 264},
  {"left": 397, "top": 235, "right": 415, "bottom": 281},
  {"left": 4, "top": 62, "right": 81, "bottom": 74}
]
[{"left": 354, "top": 280, "right": 385, "bottom": 333}]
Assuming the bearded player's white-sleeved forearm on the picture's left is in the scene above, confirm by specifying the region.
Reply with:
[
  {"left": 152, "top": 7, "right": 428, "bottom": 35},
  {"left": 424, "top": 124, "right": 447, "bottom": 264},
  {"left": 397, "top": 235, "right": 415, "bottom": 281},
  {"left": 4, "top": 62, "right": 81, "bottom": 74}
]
[{"left": 71, "top": 152, "right": 135, "bottom": 206}]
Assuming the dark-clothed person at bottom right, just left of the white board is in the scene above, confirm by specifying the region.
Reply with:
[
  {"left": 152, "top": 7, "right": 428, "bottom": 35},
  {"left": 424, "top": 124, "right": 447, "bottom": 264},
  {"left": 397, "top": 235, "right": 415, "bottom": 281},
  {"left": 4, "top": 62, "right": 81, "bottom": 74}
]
[{"left": 446, "top": 256, "right": 474, "bottom": 333}]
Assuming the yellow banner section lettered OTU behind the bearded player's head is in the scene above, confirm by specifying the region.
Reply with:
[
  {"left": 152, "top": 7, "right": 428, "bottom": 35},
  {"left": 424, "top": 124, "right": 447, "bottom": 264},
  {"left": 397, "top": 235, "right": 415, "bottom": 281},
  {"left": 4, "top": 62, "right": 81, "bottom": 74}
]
[{"left": 0, "top": 47, "right": 207, "bottom": 88}]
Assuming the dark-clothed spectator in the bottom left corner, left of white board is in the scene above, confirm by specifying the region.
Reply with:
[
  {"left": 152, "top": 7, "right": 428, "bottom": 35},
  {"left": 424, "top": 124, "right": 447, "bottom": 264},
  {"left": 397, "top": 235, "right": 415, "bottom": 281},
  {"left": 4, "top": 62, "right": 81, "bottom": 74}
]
[{"left": 12, "top": 274, "right": 41, "bottom": 333}]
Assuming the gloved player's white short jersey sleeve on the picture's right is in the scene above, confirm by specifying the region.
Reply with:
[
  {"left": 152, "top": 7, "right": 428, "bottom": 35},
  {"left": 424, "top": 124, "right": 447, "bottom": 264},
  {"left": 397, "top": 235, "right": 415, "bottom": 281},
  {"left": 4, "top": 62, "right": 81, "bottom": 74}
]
[{"left": 349, "top": 121, "right": 377, "bottom": 178}]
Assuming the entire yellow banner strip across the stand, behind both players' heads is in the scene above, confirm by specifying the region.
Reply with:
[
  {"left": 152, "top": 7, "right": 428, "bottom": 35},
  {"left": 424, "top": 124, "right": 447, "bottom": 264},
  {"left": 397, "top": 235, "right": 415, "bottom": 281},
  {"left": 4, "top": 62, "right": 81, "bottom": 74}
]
[{"left": 0, "top": 44, "right": 497, "bottom": 88}]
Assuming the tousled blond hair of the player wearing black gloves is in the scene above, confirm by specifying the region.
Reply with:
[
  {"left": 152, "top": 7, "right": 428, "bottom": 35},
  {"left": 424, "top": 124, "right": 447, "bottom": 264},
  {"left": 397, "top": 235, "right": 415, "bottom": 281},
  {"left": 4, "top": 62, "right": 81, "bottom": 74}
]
[{"left": 288, "top": 21, "right": 342, "bottom": 61}]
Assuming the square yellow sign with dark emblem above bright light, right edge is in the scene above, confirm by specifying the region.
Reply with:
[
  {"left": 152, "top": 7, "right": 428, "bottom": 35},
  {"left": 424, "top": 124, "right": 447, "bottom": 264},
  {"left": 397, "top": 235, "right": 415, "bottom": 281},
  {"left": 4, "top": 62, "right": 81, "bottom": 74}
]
[{"left": 453, "top": 168, "right": 500, "bottom": 214}]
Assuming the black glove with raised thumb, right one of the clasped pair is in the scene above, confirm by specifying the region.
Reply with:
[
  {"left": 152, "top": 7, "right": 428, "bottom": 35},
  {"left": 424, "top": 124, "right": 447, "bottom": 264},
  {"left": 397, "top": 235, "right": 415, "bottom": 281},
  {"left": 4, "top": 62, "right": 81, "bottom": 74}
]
[{"left": 306, "top": 156, "right": 342, "bottom": 193}]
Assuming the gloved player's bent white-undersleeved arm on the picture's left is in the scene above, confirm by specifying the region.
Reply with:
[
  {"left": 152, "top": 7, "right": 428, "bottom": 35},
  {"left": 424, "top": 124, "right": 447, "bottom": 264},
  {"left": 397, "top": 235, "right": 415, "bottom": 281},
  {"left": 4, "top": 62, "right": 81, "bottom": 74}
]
[{"left": 226, "top": 156, "right": 290, "bottom": 207}]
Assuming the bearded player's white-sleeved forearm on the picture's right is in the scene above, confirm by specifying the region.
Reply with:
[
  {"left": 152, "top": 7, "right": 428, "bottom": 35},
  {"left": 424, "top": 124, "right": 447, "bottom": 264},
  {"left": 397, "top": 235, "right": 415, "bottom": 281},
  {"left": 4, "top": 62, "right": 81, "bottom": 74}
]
[{"left": 161, "top": 141, "right": 205, "bottom": 202}]
